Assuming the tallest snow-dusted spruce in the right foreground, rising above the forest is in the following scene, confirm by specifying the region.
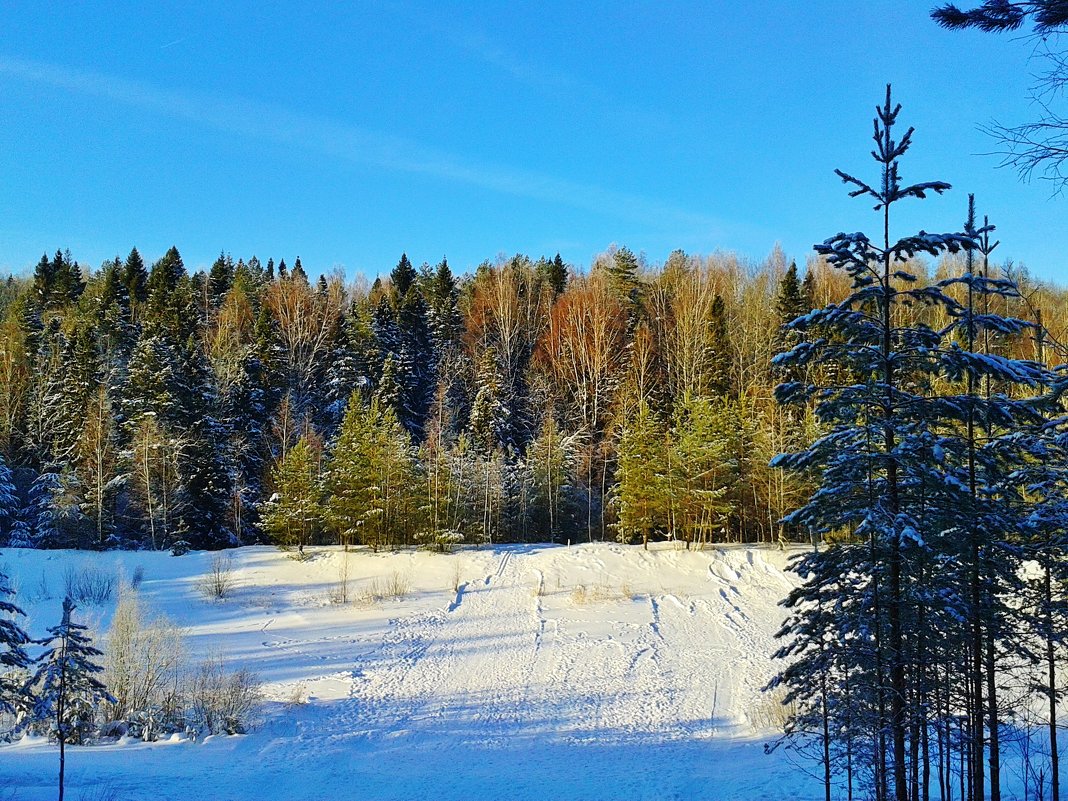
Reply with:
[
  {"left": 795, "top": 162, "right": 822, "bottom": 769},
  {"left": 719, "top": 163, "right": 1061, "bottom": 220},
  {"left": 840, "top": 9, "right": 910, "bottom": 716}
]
[{"left": 774, "top": 87, "right": 1003, "bottom": 801}]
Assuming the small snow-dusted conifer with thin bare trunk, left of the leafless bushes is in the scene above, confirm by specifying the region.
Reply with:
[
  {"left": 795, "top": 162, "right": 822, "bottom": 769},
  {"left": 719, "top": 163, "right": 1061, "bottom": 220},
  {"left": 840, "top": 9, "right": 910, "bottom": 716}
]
[{"left": 25, "top": 598, "right": 114, "bottom": 801}]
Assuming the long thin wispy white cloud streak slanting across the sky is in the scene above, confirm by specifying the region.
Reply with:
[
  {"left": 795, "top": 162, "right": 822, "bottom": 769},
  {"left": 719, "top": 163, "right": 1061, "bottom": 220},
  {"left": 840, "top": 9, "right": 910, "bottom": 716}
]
[{"left": 0, "top": 57, "right": 723, "bottom": 237}]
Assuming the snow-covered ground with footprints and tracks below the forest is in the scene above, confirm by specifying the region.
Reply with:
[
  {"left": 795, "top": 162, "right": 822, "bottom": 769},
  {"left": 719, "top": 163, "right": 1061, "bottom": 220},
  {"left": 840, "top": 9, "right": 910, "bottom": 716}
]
[{"left": 0, "top": 544, "right": 822, "bottom": 801}]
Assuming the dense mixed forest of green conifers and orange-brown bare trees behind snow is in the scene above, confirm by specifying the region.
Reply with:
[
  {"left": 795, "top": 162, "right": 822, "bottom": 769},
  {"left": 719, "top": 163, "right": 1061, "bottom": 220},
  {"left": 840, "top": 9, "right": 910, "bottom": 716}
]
[{"left": 0, "top": 208, "right": 1068, "bottom": 551}]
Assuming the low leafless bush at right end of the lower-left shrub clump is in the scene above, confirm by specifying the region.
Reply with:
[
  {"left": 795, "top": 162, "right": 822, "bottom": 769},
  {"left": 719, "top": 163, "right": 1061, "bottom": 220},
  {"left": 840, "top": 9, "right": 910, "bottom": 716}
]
[{"left": 188, "top": 659, "right": 261, "bottom": 736}]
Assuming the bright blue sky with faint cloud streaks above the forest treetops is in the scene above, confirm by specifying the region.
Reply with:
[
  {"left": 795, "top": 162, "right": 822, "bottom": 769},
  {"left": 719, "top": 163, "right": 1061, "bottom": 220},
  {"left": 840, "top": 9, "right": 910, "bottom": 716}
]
[{"left": 0, "top": 0, "right": 1068, "bottom": 283}]
